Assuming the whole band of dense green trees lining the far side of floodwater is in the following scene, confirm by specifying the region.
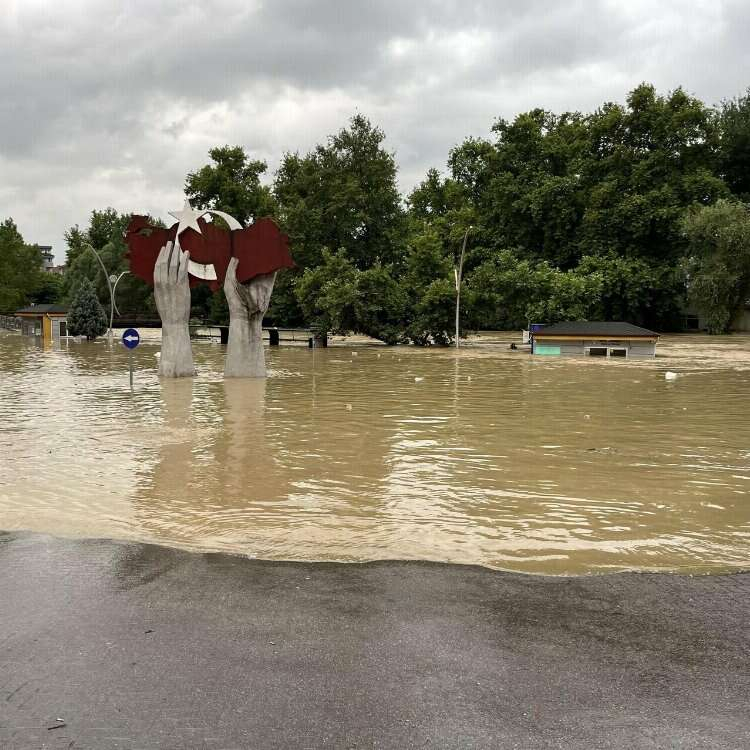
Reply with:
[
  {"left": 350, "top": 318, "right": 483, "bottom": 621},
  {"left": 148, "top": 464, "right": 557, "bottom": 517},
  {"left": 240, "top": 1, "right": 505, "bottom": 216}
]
[{"left": 5, "top": 83, "right": 750, "bottom": 344}]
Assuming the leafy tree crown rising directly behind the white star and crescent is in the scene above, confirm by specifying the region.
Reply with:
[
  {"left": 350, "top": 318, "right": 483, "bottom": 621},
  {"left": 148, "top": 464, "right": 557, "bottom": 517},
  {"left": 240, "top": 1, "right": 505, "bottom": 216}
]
[{"left": 185, "top": 146, "right": 275, "bottom": 225}]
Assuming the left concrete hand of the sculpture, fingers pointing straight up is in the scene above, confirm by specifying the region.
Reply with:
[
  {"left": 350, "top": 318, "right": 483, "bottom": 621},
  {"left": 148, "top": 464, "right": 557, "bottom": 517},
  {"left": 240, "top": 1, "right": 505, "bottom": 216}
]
[{"left": 154, "top": 242, "right": 195, "bottom": 378}]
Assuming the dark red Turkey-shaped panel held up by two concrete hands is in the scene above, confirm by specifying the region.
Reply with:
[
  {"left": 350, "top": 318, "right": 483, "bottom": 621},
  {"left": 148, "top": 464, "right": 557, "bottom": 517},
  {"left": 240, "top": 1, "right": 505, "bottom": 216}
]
[{"left": 125, "top": 216, "right": 294, "bottom": 292}]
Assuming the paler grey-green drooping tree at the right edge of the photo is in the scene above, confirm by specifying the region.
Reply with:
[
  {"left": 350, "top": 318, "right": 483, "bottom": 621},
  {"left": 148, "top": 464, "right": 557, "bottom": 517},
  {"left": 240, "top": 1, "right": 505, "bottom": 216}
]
[{"left": 682, "top": 200, "right": 750, "bottom": 333}]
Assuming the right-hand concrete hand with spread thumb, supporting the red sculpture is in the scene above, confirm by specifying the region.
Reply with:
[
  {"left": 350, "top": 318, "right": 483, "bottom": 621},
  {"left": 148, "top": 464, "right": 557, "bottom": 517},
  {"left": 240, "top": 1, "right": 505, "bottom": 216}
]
[{"left": 224, "top": 258, "right": 276, "bottom": 378}]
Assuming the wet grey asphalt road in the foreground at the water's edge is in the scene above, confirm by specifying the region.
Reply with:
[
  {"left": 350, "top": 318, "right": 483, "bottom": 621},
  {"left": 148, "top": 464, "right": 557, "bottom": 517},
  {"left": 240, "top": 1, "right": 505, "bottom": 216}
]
[{"left": 0, "top": 533, "right": 750, "bottom": 750}]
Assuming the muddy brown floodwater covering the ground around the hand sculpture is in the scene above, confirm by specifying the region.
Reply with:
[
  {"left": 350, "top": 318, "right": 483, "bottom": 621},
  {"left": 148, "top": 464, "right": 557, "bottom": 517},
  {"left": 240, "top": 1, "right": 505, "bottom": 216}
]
[{"left": 0, "top": 332, "right": 750, "bottom": 574}]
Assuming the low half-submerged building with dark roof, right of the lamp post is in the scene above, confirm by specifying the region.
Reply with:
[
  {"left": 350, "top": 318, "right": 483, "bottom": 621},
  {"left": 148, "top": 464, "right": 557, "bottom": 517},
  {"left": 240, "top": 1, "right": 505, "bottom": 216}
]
[{"left": 531, "top": 321, "right": 659, "bottom": 357}]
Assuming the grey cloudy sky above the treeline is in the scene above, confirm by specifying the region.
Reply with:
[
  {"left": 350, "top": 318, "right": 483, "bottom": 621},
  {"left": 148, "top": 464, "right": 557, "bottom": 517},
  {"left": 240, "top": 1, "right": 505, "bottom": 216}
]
[{"left": 0, "top": 0, "right": 750, "bottom": 260}]
